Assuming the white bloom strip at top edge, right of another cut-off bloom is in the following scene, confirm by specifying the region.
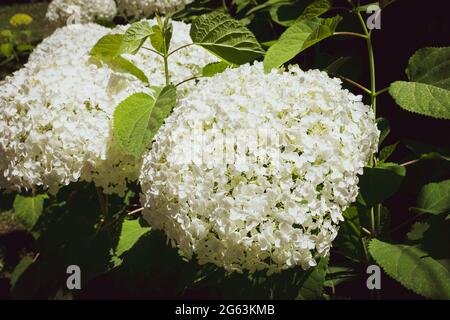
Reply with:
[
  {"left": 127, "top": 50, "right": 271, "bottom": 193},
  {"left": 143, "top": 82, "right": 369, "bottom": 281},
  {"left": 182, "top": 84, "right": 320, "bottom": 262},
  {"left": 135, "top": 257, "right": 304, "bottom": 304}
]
[{"left": 117, "top": 0, "right": 194, "bottom": 17}]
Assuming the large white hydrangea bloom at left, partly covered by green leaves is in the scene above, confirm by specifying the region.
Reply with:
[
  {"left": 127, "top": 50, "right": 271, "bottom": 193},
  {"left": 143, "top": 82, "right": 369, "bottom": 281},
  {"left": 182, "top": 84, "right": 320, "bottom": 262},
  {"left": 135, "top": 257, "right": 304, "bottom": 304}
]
[{"left": 0, "top": 20, "right": 216, "bottom": 195}]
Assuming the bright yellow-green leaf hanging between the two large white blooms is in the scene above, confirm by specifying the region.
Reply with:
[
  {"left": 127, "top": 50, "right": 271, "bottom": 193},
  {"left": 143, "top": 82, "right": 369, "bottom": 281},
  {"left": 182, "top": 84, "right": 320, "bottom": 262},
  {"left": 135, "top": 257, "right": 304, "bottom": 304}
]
[{"left": 113, "top": 85, "right": 176, "bottom": 157}]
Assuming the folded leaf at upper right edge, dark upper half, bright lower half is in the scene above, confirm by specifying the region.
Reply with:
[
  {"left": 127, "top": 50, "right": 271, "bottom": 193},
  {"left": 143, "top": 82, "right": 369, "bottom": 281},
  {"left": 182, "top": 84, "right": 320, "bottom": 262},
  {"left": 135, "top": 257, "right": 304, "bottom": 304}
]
[{"left": 389, "top": 47, "right": 450, "bottom": 120}]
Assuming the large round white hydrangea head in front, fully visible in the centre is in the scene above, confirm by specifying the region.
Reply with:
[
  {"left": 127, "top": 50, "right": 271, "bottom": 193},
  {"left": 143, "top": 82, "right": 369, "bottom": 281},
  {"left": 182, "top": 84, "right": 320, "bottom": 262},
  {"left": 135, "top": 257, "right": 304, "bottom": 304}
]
[{"left": 140, "top": 63, "right": 379, "bottom": 274}]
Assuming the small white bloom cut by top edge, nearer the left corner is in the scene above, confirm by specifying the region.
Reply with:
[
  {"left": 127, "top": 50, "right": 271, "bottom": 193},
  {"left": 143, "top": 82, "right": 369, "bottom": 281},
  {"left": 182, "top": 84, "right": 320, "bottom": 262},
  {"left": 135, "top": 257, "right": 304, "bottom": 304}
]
[{"left": 45, "top": 0, "right": 117, "bottom": 26}]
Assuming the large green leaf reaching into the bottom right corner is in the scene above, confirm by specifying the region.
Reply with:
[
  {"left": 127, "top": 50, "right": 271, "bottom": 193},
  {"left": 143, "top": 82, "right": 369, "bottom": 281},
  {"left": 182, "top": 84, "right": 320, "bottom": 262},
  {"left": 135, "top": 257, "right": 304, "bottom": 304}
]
[{"left": 369, "top": 239, "right": 450, "bottom": 299}]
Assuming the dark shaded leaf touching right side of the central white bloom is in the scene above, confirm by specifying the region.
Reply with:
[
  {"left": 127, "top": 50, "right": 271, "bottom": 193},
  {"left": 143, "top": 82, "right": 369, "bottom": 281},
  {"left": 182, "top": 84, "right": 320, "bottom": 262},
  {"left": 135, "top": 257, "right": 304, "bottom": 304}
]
[{"left": 358, "top": 162, "right": 406, "bottom": 207}]
